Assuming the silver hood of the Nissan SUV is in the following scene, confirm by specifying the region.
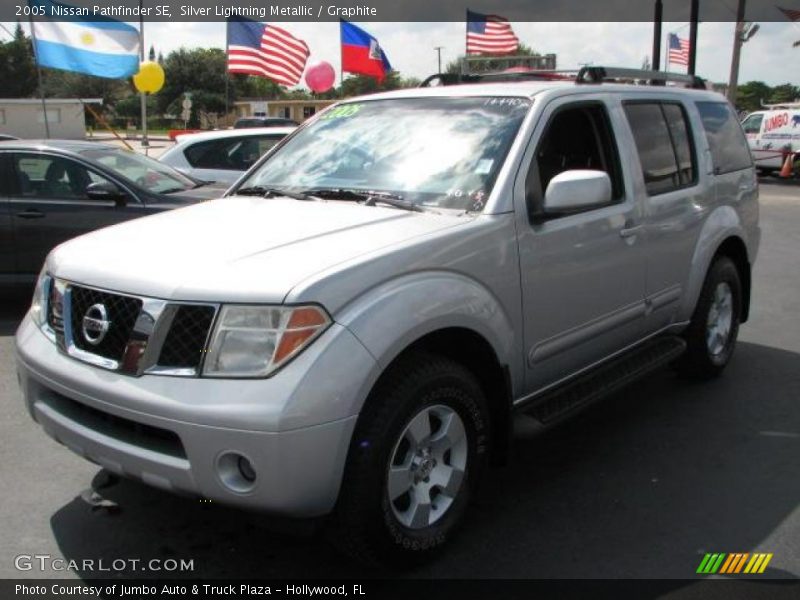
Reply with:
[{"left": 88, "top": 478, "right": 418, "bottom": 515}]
[{"left": 48, "top": 196, "right": 467, "bottom": 303}]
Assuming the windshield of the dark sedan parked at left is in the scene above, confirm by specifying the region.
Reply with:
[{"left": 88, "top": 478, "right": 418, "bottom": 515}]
[{"left": 81, "top": 148, "right": 197, "bottom": 194}]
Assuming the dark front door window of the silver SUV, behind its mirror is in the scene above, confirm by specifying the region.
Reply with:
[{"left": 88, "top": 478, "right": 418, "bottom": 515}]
[{"left": 526, "top": 104, "right": 622, "bottom": 210}]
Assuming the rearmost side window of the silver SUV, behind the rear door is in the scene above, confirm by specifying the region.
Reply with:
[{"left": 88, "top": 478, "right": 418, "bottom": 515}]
[{"left": 697, "top": 102, "right": 753, "bottom": 175}]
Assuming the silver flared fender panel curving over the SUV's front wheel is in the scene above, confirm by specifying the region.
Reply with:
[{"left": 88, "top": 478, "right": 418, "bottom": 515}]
[{"left": 336, "top": 270, "right": 522, "bottom": 409}]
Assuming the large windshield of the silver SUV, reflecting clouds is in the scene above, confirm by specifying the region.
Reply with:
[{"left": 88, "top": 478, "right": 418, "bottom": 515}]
[{"left": 237, "top": 97, "right": 531, "bottom": 211}]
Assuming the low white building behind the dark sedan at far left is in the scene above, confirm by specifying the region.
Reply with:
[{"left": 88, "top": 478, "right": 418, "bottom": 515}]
[{"left": 0, "top": 98, "right": 103, "bottom": 140}]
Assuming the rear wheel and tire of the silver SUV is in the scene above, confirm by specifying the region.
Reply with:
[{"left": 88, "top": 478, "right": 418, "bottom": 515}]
[{"left": 677, "top": 256, "right": 742, "bottom": 379}]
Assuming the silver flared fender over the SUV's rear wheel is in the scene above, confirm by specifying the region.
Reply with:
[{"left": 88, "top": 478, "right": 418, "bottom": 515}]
[{"left": 678, "top": 205, "right": 751, "bottom": 321}]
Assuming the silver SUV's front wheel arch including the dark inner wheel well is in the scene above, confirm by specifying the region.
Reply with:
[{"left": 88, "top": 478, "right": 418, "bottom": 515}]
[{"left": 335, "top": 271, "right": 522, "bottom": 463}]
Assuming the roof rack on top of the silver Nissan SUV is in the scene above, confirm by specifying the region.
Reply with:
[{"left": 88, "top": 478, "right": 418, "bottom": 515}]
[{"left": 420, "top": 66, "right": 706, "bottom": 89}]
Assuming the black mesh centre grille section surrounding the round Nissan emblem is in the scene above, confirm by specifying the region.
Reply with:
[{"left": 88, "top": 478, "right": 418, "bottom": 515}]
[{"left": 70, "top": 286, "right": 142, "bottom": 361}]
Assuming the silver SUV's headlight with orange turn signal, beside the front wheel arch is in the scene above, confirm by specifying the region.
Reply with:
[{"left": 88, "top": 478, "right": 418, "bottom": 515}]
[{"left": 203, "top": 305, "right": 331, "bottom": 377}]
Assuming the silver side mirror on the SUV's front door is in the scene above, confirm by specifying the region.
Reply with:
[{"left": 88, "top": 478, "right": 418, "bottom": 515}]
[{"left": 544, "top": 169, "right": 611, "bottom": 215}]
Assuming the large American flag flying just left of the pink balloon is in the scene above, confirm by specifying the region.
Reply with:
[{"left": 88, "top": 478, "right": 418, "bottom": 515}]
[{"left": 228, "top": 18, "right": 309, "bottom": 85}]
